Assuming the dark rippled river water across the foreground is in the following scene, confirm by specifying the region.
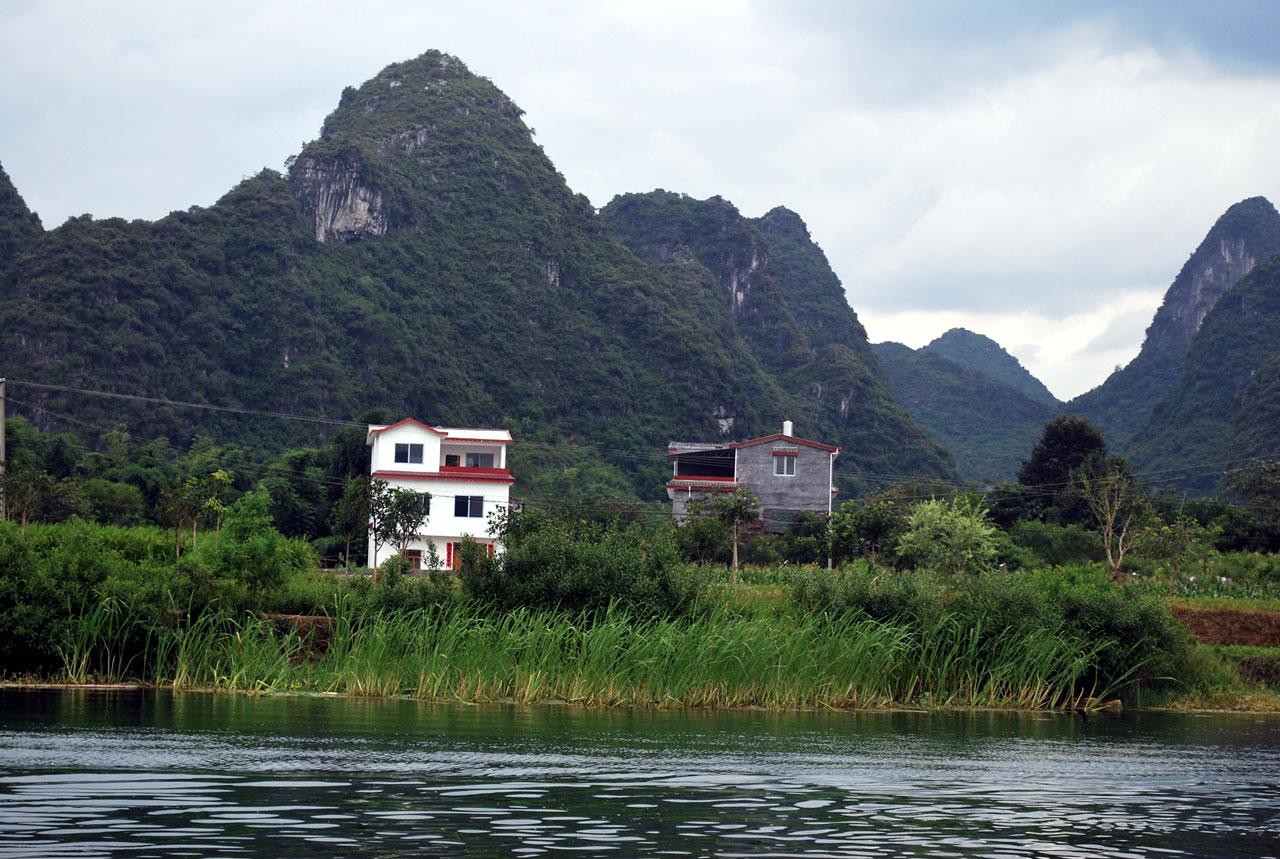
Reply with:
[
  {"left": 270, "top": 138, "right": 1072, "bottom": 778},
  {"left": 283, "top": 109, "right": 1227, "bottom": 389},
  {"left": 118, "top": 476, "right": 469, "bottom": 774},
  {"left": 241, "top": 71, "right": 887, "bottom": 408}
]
[{"left": 0, "top": 691, "right": 1280, "bottom": 856}]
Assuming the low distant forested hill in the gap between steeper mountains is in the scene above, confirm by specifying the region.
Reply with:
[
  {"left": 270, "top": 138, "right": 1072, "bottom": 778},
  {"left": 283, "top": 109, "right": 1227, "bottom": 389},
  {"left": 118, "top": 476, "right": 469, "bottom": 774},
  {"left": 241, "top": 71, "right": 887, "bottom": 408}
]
[{"left": 872, "top": 340, "right": 1060, "bottom": 484}]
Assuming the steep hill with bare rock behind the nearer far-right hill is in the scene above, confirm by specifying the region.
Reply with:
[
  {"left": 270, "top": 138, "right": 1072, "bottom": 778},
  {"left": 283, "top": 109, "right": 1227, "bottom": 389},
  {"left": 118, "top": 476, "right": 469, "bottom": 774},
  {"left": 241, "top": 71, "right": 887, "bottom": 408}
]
[{"left": 1066, "top": 197, "right": 1280, "bottom": 449}]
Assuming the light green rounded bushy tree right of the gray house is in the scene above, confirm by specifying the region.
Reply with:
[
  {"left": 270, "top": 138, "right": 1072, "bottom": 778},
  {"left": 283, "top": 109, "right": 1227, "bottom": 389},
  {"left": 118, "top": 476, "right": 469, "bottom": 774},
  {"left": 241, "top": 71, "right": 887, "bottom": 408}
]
[{"left": 897, "top": 495, "right": 996, "bottom": 574}]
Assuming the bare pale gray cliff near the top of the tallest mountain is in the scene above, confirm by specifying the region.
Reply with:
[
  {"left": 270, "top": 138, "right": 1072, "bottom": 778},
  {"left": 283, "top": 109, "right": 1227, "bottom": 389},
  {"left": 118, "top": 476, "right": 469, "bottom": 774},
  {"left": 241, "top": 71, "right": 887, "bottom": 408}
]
[{"left": 293, "top": 157, "right": 387, "bottom": 242}]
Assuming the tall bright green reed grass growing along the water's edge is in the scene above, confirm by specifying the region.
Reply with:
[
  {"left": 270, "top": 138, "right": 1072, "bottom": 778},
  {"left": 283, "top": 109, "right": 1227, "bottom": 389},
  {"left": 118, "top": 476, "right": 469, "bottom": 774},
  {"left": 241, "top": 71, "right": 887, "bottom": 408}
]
[{"left": 68, "top": 603, "right": 1111, "bottom": 709}]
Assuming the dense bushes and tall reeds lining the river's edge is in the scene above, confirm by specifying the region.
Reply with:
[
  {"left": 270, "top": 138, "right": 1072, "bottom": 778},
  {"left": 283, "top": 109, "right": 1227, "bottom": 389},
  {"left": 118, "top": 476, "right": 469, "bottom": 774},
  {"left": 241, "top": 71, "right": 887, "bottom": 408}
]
[{"left": 0, "top": 522, "right": 1256, "bottom": 709}]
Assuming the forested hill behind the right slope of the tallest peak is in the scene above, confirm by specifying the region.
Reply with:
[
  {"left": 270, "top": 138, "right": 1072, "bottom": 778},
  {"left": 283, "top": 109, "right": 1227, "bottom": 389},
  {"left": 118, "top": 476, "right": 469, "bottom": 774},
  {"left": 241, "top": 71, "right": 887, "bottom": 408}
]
[{"left": 600, "top": 191, "right": 954, "bottom": 486}]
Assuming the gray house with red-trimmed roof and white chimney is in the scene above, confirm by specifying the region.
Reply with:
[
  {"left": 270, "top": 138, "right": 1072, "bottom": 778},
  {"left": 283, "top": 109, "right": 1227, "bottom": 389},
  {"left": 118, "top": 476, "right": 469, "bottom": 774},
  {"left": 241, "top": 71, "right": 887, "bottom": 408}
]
[{"left": 667, "top": 421, "right": 840, "bottom": 531}]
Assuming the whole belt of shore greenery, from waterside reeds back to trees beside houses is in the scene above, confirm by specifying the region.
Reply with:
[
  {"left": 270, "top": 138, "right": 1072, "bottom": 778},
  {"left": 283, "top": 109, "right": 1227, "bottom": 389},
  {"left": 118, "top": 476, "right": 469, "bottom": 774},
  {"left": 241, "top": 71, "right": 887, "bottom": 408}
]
[{"left": 0, "top": 409, "right": 1280, "bottom": 709}]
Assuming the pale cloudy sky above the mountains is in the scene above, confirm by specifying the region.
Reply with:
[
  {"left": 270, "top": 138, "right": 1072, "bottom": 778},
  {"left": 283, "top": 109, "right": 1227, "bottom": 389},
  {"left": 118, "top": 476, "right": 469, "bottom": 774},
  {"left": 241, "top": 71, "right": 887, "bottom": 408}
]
[{"left": 0, "top": 0, "right": 1280, "bottom": 399}]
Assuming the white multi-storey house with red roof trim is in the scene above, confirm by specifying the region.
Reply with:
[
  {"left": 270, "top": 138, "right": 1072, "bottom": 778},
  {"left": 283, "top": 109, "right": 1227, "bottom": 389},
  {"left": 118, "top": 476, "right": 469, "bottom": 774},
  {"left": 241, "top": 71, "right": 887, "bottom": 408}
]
[{"left": 365, "top": 417, "right": 515, "bottom": 570}]
